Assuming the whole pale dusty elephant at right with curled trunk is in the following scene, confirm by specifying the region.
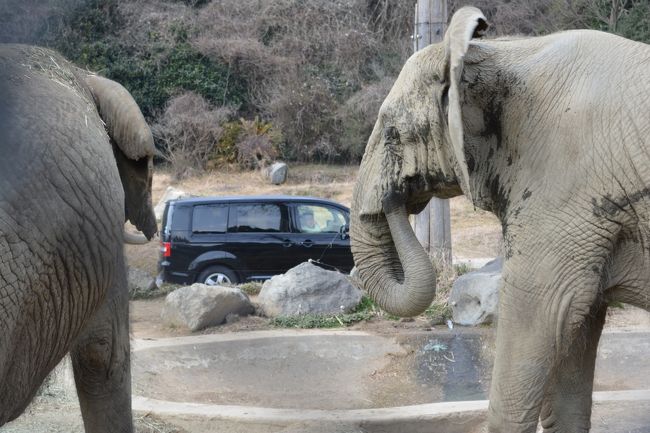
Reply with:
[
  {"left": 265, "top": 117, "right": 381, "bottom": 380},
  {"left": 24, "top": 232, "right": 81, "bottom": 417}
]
[{"left": 351, "top": 8, "right": 650, "bottom": 433}]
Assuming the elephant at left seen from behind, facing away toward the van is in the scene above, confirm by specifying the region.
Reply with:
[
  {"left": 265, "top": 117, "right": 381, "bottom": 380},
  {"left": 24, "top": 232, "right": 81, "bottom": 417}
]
[{"left": 0, "top": 45, "right": 156, "bottom": 433}]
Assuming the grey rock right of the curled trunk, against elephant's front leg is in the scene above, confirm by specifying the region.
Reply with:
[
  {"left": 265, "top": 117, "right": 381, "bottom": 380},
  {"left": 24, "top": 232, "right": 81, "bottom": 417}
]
[{"left": 449, "top": 258, "right": 503, "bottom": 326}]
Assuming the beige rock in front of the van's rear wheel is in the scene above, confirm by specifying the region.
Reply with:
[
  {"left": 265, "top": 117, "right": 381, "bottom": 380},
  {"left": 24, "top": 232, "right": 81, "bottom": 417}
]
[{"left": 162, "top": 283, "right": 255, "bottom": 331}]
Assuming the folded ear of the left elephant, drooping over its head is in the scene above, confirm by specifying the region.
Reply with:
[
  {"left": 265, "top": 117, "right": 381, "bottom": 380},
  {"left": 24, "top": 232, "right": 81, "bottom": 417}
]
[{"left": 85, "top": 75, "right": 157, "bottom": 239}]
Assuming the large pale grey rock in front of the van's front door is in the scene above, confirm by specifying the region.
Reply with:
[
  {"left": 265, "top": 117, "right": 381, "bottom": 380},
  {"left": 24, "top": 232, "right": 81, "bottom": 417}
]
[{"left": 257, "top": 262, "right": 363, "bottom": 317}]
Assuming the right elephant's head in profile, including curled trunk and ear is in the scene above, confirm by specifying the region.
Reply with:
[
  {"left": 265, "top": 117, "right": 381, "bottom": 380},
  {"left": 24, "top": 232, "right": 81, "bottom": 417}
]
[{"left": 351, "top": 8, "right": 487, "bottom": 316}]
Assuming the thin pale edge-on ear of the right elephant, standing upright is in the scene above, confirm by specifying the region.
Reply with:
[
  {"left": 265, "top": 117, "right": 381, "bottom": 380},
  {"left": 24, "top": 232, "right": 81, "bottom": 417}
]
[{"left": 444, "top": 7, "right": 488, "bottom": 201}]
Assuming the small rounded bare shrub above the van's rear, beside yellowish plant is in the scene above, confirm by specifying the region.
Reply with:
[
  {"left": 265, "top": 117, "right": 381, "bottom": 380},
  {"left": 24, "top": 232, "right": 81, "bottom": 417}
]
[{"left": 152, "top": 92, "right": 233, "bottom": 178}]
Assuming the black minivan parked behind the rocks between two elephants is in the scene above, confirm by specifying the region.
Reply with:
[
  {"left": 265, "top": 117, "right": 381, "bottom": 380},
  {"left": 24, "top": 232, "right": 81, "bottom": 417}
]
[{"left": 159, "top": 196, "right": 354, "bottom": 285}]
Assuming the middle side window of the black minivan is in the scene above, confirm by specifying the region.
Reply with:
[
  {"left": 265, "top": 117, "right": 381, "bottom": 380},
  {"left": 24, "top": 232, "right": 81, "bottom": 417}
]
[{"left": 228, "top": 204, "right": 283, "bottom": 233}]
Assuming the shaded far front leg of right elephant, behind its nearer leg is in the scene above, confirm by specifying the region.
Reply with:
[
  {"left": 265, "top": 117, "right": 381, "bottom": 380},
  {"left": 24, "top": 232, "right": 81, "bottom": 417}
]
[{"left": 540, "top": 305, "right": 607, "bottom": 433}]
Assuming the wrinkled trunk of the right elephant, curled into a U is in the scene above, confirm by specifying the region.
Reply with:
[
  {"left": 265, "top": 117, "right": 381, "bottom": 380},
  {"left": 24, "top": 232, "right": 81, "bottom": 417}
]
[{"left": 350, "top": 189, "right": 436, "bottom": 317}]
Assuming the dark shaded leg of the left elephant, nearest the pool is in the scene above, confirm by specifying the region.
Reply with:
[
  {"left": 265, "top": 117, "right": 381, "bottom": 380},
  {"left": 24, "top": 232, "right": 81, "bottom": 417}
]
[{"left": 71, "top": 282, "right": 134, "bottom": 433}]
